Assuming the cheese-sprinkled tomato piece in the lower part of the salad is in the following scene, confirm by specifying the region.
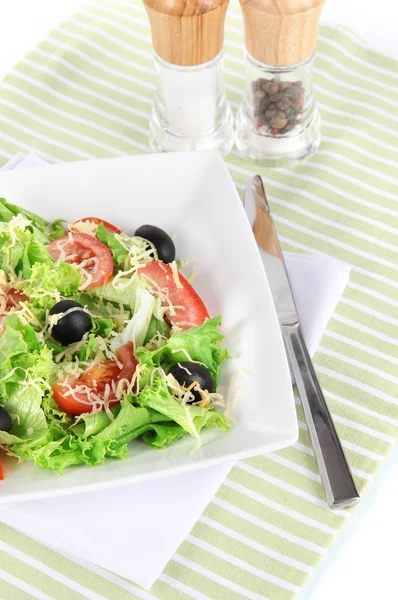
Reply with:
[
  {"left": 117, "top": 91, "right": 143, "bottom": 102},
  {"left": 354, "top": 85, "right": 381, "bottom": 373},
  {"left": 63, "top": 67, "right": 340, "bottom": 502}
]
[{"left": 53, "top": 342, "right": 137, "bottom": 415}]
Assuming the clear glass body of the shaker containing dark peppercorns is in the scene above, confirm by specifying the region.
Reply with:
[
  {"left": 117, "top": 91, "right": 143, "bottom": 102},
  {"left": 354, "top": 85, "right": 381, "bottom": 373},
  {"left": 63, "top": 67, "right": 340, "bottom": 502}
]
[{"left": 236, "top": 52, "right": 320, "bottom": 167}]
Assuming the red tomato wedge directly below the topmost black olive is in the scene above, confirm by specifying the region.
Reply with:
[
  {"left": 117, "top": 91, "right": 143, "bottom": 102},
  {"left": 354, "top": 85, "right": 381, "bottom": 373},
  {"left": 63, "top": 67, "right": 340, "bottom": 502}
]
[{"left": 140, "top": 260, "right": 209, "bottom": 329}]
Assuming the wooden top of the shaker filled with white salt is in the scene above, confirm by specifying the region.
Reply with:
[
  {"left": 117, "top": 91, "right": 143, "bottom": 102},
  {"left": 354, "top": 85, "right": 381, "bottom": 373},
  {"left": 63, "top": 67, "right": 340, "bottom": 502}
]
[{"left": 143, "top": 0, "right": 229, "bottom": 67}]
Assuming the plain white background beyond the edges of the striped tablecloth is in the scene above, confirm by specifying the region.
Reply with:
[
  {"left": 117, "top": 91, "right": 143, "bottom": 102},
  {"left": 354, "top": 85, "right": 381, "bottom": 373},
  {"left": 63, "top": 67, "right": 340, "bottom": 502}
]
[{"left": 0, "top": 0, "right": 398, "bottom": 600}]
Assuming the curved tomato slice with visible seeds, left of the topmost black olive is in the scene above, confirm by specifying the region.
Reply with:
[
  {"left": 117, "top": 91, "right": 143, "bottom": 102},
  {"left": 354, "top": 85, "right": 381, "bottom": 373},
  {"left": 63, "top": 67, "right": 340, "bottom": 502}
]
[{"left": 47, "top": 233, "right": 113, "bottom": 290}]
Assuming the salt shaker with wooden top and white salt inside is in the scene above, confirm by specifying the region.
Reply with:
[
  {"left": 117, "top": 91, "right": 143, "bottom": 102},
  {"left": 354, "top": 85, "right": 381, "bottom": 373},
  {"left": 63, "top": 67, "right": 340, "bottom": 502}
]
[{"left": 143, "top": 0, "right": 234, "bottom": 154}]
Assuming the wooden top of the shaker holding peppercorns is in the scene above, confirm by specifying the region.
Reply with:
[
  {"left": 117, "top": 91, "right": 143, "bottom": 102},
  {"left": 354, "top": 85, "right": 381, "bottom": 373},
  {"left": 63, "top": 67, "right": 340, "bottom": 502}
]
[{"left": 239, "top": 0, "right": 324, "bottom": 66}]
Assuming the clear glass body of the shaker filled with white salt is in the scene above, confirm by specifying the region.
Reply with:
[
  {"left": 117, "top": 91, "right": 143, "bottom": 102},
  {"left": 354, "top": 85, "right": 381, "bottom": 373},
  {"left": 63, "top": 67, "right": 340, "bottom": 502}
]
[{"left": 150, "top": 52, "right": 234, "bottom": 154}]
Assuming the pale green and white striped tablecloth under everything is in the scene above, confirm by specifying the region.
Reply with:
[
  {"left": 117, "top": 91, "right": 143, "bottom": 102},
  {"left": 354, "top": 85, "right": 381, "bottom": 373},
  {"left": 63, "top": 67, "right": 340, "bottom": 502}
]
[{"left": 0, "top": 0, "right": 398, "bottom": 600}]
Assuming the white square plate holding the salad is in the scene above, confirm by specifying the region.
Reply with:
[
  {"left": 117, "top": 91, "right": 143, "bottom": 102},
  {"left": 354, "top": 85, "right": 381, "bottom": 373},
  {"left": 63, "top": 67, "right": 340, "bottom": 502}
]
[{"left": 0, "top": 153, "right": 298, "bottom": 502}]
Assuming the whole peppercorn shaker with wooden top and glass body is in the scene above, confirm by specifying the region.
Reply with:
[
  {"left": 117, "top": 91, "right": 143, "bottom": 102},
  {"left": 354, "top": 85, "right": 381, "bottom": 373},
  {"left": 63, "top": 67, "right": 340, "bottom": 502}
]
[{"left": 236, "top": 0, "right": 324, "bottom": 167}]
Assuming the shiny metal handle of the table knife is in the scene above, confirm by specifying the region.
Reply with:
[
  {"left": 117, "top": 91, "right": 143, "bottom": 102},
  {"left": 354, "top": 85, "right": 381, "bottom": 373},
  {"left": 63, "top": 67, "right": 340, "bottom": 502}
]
[{"left": 282, "top": 324, "right": 360, "bottom": 508}]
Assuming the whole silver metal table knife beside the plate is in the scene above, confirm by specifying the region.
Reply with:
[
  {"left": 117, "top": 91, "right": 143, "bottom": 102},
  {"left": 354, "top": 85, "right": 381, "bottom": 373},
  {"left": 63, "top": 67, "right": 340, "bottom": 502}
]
[{"left": 245, "top": 175, "right": 360, "bottom": 509}]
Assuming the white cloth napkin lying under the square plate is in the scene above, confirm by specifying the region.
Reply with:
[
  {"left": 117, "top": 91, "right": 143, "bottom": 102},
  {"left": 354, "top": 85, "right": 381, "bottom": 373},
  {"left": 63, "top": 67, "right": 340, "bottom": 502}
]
[{"left": 0, "top": 153, "right": 349, "bottom": 589}]
